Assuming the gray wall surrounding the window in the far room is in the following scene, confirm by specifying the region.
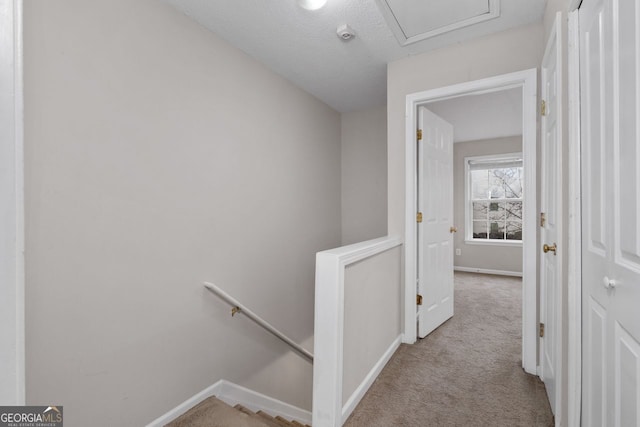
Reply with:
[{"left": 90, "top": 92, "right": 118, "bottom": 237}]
[{"left": 453, "top": 136, "right": 522, "bottom": 273}]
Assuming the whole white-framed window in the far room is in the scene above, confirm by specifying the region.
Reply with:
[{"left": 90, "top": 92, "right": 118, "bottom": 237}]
[{"left": 465, "top": 153, "right": 524, "bottom": 244}]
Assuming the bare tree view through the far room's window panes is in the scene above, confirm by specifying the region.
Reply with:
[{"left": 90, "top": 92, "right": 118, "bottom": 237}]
[{"left": 469, "top": 166, "right": 523, "bottom": 241}]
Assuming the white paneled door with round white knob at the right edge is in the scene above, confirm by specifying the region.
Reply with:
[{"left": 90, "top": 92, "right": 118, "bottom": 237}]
[{"left": 579, "top": 0, "right": 640, "bottom": 426}]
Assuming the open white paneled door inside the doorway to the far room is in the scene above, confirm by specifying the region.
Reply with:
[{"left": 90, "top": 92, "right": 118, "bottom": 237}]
[{"left": 417, "top": 107, "right": 453, "bottom": 338}]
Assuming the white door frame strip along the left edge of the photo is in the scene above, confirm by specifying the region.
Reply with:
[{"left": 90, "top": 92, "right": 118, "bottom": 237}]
[{"left": 0, "top": 0, "right": 26, "bottom": 405}]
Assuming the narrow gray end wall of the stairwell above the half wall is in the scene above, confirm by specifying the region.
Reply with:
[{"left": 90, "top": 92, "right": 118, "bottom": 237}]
[{"left": 342, "top": 107, "right": 387, "bottom": 245}]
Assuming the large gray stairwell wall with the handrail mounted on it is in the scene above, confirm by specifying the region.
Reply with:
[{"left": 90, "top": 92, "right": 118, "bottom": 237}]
[{"left": 24, "top": 0, "right": 341, "bottom": 427}]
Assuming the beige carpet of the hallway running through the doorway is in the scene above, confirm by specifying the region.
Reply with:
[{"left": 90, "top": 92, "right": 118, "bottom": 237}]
[{"left": 345, "top": 272, "right": 553, "bottom": 427}]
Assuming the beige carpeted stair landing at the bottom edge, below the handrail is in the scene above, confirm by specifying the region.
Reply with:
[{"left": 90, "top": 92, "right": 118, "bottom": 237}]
[{"left": 165, "top": 396, "right": 272, "bottom": 427}]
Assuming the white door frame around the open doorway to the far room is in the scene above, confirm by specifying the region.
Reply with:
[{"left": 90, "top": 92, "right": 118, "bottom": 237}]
[{"left": 403, "top": 68, "right": 538, "bottom": 375}]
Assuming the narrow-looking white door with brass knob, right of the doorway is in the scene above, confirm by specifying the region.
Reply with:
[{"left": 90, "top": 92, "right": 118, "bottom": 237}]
[{"left": 540, "top": 13, "right": 563, "bottom": 415}]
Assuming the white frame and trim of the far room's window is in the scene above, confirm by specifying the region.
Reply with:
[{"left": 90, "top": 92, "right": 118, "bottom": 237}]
[{"left": 464, "top": 152, "right": 525, "bottom": 247}]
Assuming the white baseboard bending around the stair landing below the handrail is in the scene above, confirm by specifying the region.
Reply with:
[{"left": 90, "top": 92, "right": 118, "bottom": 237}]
[{"left": 146, "top": 380, "right": 311, "bottom": 427}]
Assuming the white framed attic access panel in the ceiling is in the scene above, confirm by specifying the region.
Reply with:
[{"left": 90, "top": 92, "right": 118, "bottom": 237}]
[{"left": 376, "top": 0, "right": 500, "bottom": 46}]
